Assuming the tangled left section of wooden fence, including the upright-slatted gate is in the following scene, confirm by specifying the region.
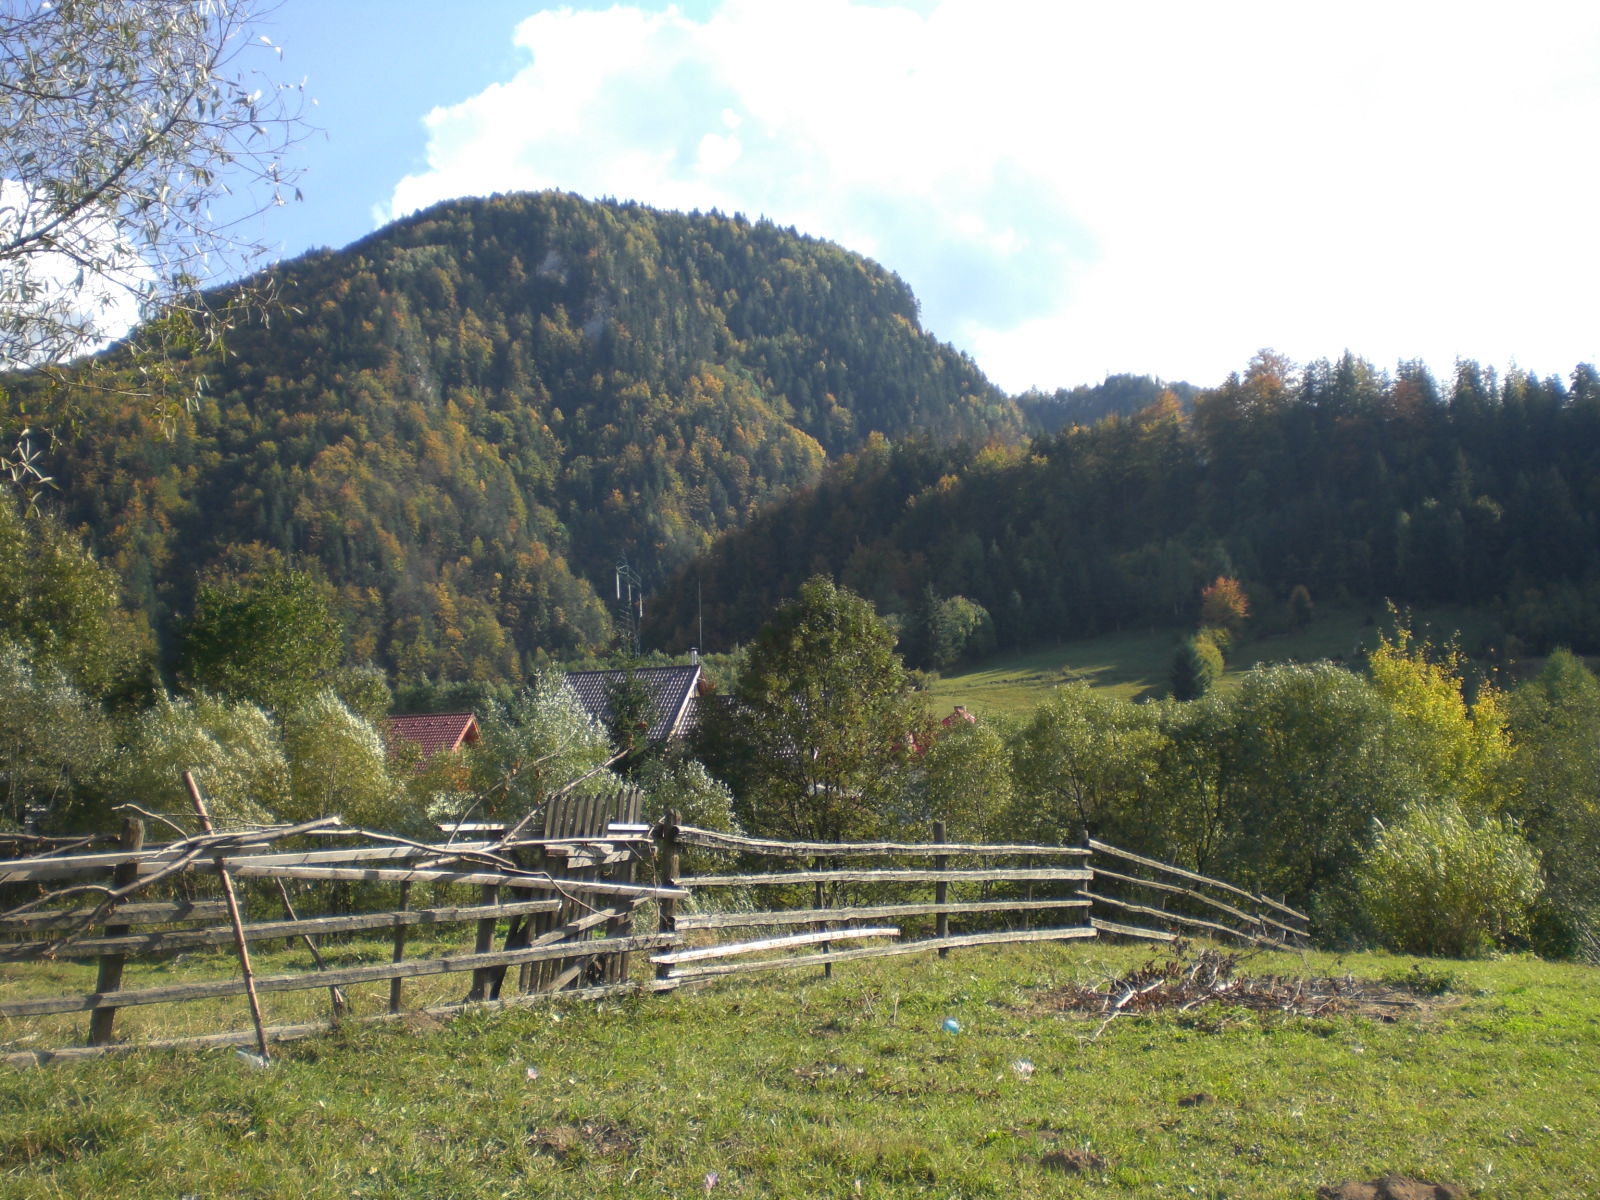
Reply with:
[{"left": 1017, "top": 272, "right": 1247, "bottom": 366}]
[{"left": 0, "top": 790, "right": 665, "bottom": 1064}]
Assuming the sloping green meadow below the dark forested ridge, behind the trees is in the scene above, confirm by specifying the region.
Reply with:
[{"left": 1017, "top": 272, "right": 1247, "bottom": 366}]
[{"left": 926, "top": 608, "right": 1486, "bottom": 717}]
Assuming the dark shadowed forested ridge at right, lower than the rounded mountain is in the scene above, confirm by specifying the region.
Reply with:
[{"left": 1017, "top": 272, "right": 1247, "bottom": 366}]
[{"left": 651, "top": 352, "right": 1600, "bottom": 653}]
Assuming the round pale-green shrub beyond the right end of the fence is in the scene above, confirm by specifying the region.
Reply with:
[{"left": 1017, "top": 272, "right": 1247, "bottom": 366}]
[{"left": 1358, "top": 800, "right": 1541, "bottom": 958}]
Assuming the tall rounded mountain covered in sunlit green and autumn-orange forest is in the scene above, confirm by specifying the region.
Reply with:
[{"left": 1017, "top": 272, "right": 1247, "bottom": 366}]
[{"left": 25, "top": 192, "right": 1021, "bottom": 678}]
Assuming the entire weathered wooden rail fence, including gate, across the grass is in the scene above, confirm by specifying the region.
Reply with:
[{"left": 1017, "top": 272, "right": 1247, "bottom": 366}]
[{"left": 0, "top": 809, "right": 1306, "bottom": 1066}]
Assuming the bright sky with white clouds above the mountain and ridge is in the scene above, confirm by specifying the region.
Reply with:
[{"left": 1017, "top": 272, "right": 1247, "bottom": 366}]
[{"left": 233, "top": 0, "right": 1600, "bottom": 392}]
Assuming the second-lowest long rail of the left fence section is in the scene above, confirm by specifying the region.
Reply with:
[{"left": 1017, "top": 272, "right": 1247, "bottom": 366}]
[{"left": 0, "top": 934, "right": 675, "bottom": 1018}]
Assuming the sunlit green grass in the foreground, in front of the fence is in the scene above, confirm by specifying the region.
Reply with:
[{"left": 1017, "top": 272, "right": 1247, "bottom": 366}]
[{"left": 0, "top": 946, "right": 1600, "bottom": 1200}]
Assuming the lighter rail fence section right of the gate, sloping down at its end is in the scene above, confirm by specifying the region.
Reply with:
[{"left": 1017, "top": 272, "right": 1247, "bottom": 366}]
[{"left": 651, "top": 814, "right": 1307, "bottom": 986}]
